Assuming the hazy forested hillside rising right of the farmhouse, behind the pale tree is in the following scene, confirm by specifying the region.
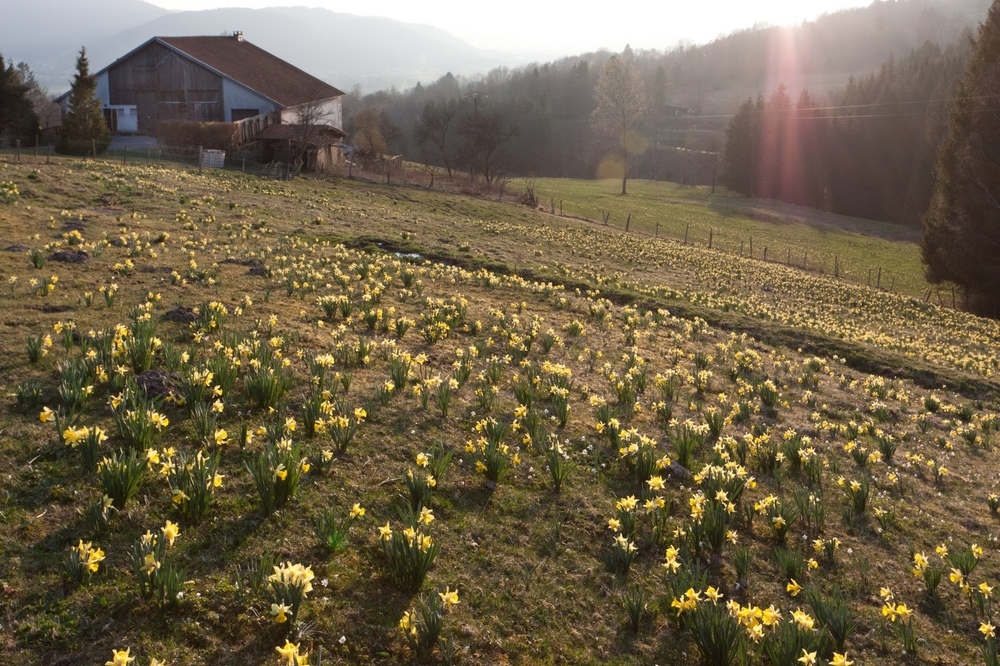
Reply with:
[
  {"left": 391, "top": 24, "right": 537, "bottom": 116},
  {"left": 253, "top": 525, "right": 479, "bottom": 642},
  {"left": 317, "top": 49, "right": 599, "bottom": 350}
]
[{"left": 345, "top": 0, "right": 988, "bottom": 224}]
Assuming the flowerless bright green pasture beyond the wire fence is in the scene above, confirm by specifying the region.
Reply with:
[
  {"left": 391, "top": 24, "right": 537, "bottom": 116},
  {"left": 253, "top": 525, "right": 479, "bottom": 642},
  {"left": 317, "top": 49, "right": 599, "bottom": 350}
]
[{"left": 536, "top": 178, "right": 930, "bottom": 297}]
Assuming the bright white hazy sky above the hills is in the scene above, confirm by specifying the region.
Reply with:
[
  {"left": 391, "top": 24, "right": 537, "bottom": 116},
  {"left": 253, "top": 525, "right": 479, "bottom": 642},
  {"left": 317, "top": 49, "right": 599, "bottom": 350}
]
[{"left": 148, "top": 0, "right": 871, "bottom": 55}]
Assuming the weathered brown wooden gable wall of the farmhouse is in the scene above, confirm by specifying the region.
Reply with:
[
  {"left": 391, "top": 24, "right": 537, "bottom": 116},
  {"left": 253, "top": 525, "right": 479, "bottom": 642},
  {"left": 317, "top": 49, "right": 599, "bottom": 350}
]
[{"left": 108, "top": 43, "right": 228, "bottom": 134}]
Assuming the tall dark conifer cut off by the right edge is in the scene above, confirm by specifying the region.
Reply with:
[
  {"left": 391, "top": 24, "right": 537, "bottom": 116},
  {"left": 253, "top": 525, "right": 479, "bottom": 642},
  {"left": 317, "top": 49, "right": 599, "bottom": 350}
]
[{"left": 922, "top": 0, "right": 1000, "bottom": 317}]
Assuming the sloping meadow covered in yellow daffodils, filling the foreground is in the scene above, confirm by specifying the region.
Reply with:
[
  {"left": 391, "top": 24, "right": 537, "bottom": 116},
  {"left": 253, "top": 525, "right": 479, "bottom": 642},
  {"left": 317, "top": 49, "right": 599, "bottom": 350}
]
[{"left": 0, "top": 160, "right": 1000, "bottom": 666}]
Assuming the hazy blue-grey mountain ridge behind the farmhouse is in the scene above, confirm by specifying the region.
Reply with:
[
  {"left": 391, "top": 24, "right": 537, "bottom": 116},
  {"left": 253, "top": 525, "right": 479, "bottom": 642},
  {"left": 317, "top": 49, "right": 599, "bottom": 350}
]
[{"left": 0, "top": 0, "right": 515, "bottom": 92}]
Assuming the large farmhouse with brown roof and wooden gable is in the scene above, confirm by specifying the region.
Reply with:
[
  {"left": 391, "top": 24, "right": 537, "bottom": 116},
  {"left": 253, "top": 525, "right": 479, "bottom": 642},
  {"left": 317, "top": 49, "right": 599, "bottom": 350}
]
[{"left": 56, "top": 32, "right": 344, "bottom": 157}]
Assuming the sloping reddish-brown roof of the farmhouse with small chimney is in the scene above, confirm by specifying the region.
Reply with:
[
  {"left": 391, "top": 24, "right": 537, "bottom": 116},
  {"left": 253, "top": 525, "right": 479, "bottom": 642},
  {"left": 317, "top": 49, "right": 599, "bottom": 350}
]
[{"left": 156, "top": 34, "right": 344, "bottom": 108}]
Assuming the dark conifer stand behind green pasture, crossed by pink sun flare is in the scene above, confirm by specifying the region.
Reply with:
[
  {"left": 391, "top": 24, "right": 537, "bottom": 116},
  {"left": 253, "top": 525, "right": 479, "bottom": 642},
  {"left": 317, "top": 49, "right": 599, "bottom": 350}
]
[{"left": 721, "top": 38, "right": 972, "bottom": 226}]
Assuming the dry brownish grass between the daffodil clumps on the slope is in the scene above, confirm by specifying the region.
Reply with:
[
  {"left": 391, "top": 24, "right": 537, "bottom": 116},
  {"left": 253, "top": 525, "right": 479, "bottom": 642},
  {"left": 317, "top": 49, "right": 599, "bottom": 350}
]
[{"left": 0, "top": 161, "right": 1000, "bottom": 666}]
